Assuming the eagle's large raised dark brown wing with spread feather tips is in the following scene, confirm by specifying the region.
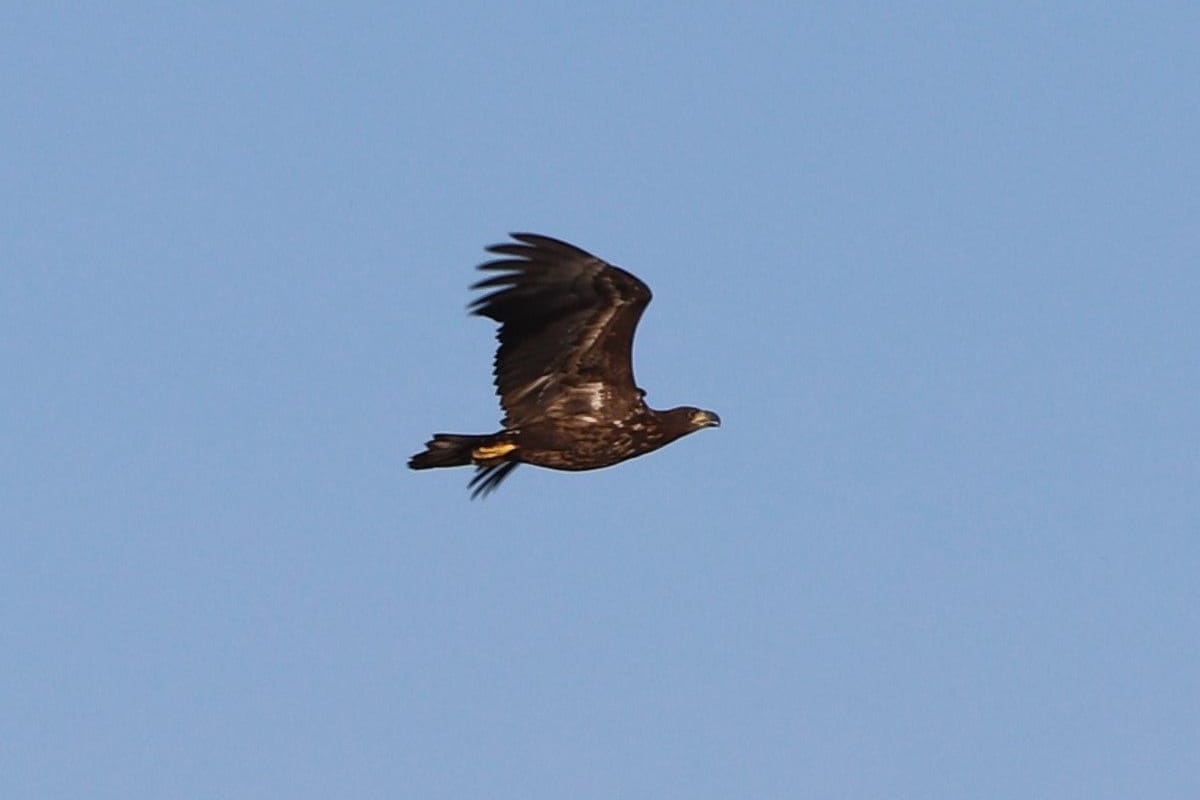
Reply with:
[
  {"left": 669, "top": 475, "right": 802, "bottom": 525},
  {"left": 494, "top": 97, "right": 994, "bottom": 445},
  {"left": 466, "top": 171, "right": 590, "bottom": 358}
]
[{"left": 472, "top": 234, "right": 650, "bottom": 427}]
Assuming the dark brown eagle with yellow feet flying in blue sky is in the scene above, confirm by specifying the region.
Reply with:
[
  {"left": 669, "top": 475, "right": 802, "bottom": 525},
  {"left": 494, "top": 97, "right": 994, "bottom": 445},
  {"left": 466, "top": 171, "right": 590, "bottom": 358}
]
[{"left": 408, "top": 233, "right": 721, "bottom": 498}]
